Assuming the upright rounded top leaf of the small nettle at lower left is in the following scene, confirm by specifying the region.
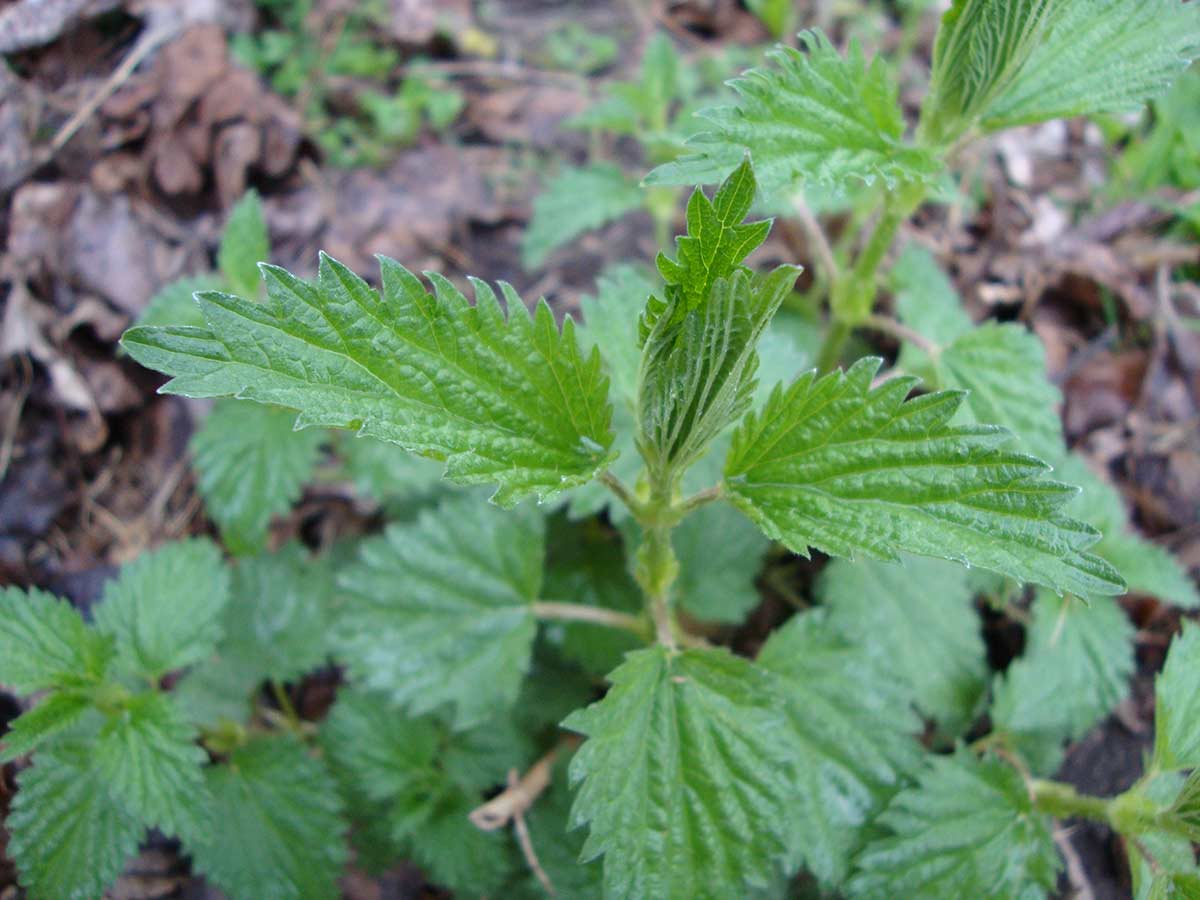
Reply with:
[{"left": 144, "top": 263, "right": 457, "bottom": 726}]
[{"left": 95, "top": 538, "right": 229, "bottom": 679}]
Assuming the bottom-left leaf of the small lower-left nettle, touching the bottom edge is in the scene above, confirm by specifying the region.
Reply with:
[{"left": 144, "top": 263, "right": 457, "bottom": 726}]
[{"left": 6, "top": 742, "right": 145, "bottom": 900}]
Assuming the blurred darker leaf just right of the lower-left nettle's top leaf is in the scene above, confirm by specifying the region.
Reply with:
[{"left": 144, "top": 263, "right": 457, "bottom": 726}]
[{"left": 221, "top": 544, "right": 334, "bottom": 682}]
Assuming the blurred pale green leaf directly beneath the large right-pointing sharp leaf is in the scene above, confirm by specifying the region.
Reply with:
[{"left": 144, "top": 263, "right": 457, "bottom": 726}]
[{"left": 817, "top": 557, "right": 988, "bottom": 734}]
